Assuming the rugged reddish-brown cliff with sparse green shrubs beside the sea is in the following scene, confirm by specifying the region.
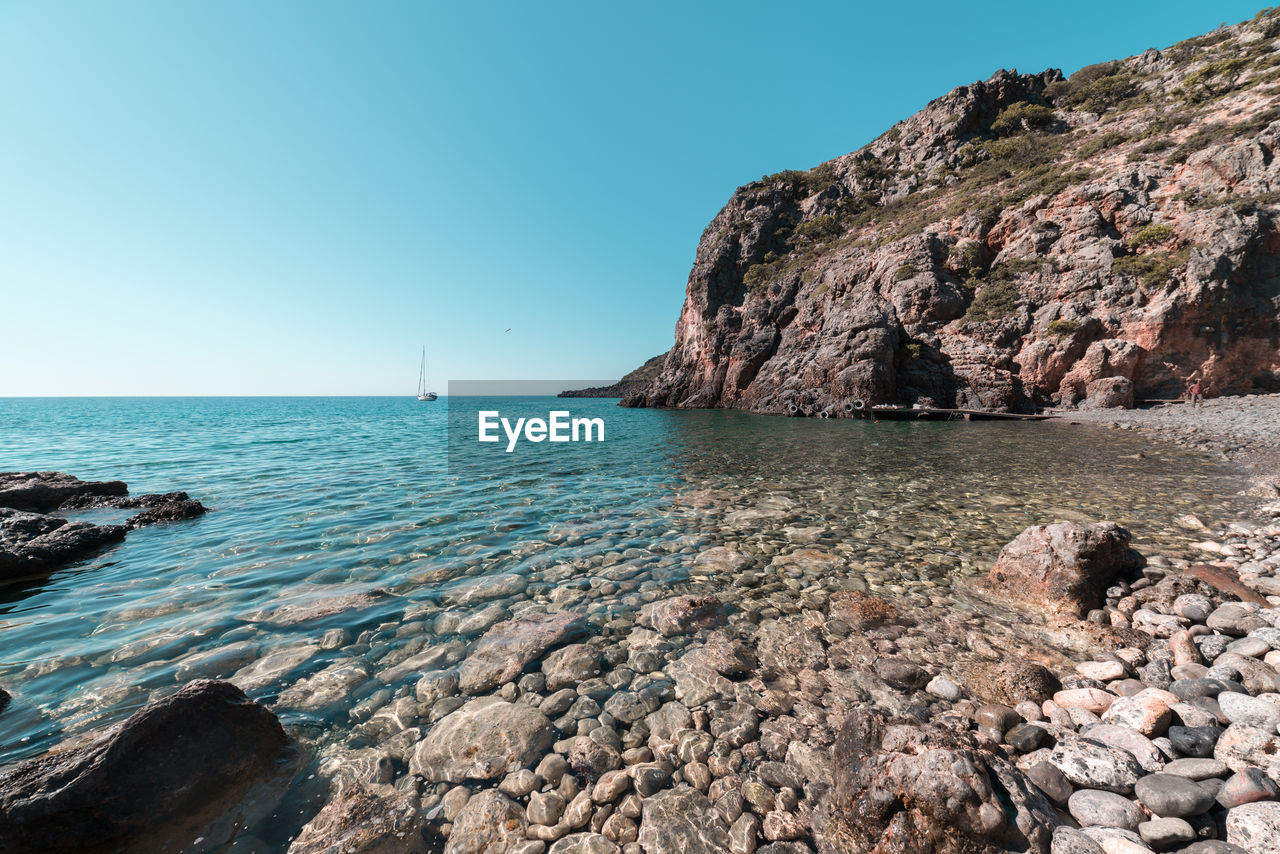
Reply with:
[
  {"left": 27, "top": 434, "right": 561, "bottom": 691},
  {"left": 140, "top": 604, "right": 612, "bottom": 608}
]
[{"left": 623, "top": 14, "right": 1280, "bottom": 414}]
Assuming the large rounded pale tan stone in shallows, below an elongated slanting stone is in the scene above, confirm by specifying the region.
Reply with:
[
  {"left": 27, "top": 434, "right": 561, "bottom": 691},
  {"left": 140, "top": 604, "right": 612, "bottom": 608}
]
[{"left": 410, "top": 697, "right": 552, "bottom": 782}]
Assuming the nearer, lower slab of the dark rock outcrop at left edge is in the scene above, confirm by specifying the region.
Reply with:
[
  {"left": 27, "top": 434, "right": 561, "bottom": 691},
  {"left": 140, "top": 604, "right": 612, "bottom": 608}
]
[{"left": 0, "top": 507, "right": 128, "bottom": 583}]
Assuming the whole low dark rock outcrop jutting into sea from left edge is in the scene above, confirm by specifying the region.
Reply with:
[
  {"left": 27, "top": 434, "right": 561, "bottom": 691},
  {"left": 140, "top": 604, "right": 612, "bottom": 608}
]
[{"left": 0, "top": 471, "right": 207, "bottom": 584}]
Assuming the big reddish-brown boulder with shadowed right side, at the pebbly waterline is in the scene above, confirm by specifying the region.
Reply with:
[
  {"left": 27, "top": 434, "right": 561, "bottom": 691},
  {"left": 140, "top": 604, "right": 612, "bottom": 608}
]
[{"left": 987, "top": 522, "right": 1144, "bottom": 617}]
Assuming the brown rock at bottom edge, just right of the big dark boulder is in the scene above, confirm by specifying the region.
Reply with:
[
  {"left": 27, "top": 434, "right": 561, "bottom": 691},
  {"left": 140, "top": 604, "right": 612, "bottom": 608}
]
[{"left": 289, "top": 785, "right": 429, "bottom": 854}]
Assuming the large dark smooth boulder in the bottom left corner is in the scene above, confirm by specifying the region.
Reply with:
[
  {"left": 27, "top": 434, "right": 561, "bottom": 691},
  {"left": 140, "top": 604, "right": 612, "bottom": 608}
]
[{"left": 0, "top": 680, "right": 301, "bottom": 854}]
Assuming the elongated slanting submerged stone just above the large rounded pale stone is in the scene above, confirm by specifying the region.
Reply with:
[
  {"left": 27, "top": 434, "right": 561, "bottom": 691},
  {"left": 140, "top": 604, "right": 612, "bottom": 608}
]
[{"left": 458, "top": 611, "right": 586, "bottom": 694}]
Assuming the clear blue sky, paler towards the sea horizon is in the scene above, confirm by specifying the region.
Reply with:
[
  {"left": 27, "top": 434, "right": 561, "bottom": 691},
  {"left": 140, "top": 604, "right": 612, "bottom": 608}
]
[{"left": 0, "top": 0, "right": 1260, "bottom": 396}]
